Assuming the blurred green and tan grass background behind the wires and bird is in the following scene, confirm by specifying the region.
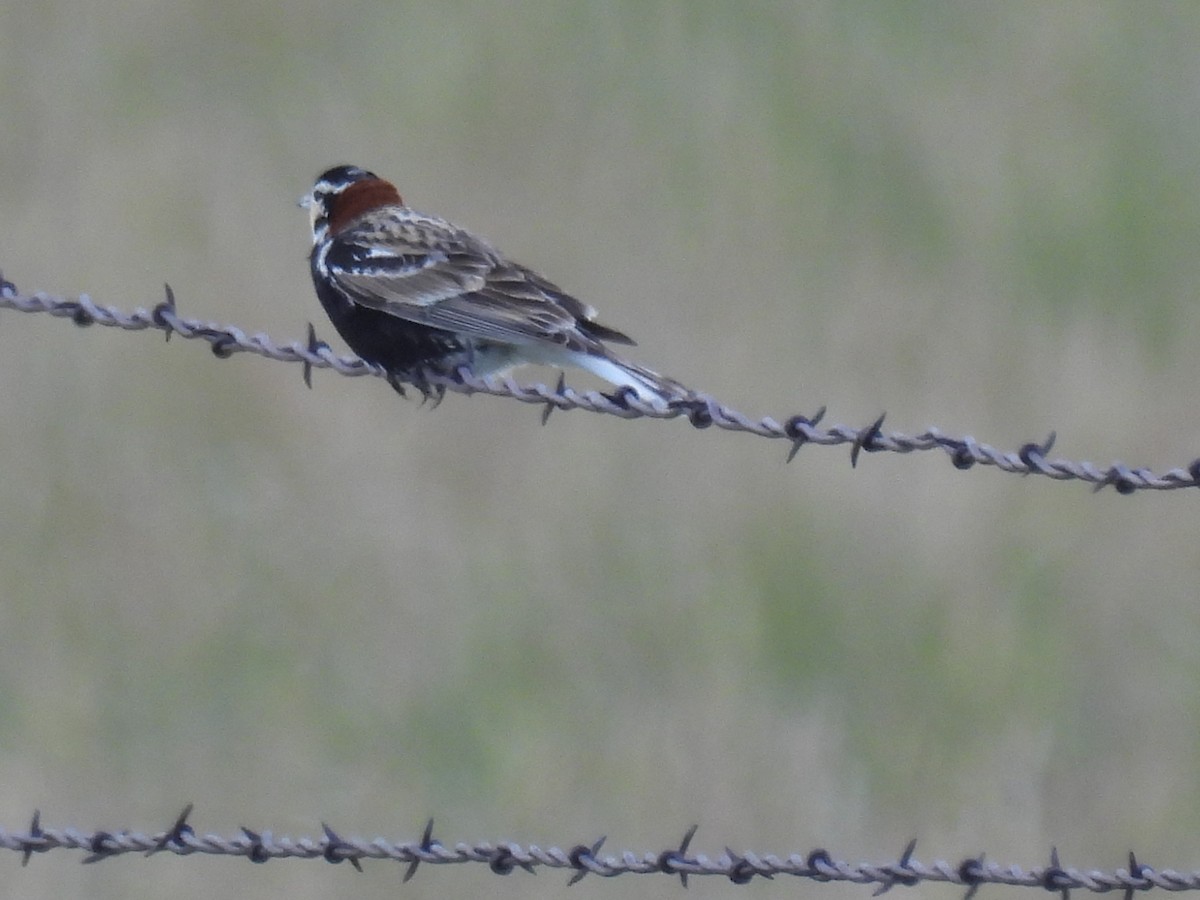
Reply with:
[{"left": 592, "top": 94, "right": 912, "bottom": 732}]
[{"left": 0, "top": 0, "right": 1200, "bottom": 900}]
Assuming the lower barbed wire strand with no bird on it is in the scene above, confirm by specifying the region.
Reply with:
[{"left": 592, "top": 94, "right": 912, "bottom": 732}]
[{"left": 0, "top": 804, "right": 1200, "bottom": 900}]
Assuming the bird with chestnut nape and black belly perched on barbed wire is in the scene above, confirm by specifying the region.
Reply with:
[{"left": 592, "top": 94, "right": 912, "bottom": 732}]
[{"left": 300, "top": 166, "right": 691, "bottom": 402}]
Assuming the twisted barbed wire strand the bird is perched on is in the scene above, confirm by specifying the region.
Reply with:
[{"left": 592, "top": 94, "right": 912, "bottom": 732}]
[{"left": 0, "top": 271, "right": 1200, "bottom": 494}]
